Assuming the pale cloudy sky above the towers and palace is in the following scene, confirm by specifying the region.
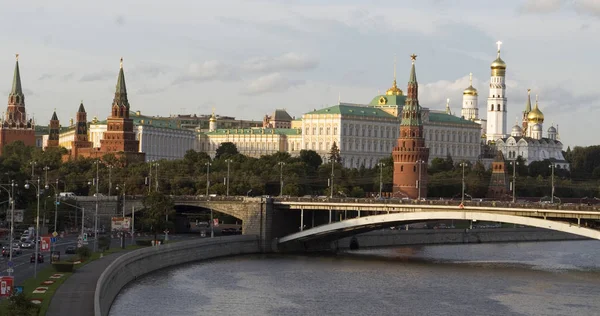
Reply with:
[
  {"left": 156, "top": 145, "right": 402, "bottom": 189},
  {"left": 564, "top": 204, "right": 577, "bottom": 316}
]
[{"left": 0, "top": 0, "right": 600, "bottom": 148}]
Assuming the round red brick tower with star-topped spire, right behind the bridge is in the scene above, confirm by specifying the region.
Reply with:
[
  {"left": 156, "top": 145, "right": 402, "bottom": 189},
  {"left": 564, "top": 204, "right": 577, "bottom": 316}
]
[{"left": 392, "top": 54, "right": 429, "bottom": 199}]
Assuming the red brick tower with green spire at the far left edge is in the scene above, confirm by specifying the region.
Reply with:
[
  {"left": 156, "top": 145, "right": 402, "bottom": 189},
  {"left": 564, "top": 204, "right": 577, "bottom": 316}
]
[{"left": 0, "top": 54, "right": 35, "bottom": 150}]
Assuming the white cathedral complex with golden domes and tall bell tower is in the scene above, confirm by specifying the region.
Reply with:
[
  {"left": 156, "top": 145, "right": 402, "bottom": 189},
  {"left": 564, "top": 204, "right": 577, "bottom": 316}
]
[{"left": 461, "top": 42, "right": 570, "bottom": 170}]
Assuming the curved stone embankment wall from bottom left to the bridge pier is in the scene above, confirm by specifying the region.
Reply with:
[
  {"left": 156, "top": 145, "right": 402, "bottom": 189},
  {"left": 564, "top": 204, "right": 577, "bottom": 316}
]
[{"left": 94, "top": 235, "right": 260, "bottom": 316}]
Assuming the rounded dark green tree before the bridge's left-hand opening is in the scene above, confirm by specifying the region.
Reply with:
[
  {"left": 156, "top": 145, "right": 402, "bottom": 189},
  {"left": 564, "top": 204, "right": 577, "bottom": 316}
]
[{"left": 142, "top": 192, "right": 175, "bottom": 240}]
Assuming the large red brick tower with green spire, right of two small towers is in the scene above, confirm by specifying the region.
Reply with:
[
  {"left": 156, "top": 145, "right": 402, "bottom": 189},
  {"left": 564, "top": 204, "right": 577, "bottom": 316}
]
[{"left": 100, "top": 58, "right": 144, "bottom": 159}]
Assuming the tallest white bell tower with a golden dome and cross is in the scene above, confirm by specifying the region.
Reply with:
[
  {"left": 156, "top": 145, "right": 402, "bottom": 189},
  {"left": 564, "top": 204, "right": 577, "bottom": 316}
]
[{"left": 486, "top": 41, "right": 507, "bottom": 143}]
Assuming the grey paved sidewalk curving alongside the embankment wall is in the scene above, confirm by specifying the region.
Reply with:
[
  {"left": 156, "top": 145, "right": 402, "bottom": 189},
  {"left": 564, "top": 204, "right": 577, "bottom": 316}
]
[{"left": 46, "top": 251, "right": 128, "bottom": 316}]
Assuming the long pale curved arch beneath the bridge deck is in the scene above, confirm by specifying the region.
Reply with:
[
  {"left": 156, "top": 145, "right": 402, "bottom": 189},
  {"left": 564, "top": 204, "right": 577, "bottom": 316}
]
[{"left": 278, "top": 211, "right": 600, "bottom": 244}]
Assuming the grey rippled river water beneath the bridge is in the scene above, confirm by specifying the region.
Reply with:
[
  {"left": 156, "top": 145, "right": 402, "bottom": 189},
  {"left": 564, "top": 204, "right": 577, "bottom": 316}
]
[{"left": 110, "top": 241, "right": 600, "bottom": 316}]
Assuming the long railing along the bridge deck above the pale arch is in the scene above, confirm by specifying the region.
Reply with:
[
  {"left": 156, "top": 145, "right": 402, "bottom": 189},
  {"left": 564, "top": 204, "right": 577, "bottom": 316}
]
[{"left": 273, "top": 197, "right": 600, "bottom": 211}]
